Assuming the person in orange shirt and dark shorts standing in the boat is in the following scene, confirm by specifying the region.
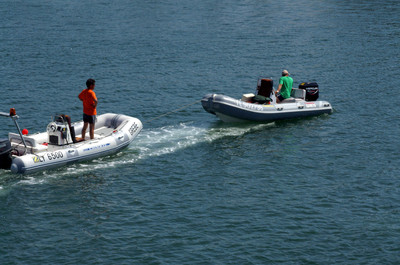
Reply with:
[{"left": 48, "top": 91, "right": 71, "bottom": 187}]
[{"left": 78, "top": 78, "right": 97, "bottom": 141}]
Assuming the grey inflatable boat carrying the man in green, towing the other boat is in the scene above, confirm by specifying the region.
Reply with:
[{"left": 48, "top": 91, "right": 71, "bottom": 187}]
[{"left": 201, "top": 79, "right": 332, "bottom": 122}]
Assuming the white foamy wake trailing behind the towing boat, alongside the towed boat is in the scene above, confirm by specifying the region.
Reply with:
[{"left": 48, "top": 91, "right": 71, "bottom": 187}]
[{"left": 0, "top": 122, "right": 273, "bottom": 191}]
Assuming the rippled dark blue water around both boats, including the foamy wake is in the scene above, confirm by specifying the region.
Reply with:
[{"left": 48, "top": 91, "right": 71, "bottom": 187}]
[{"left": 0, "top": 0, "right": 400, "bottom": 264}]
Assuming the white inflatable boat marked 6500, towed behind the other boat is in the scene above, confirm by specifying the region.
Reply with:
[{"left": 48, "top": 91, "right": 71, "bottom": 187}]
[{"left": 0, "top": 109, "right": 143, "bottom": 174}]
